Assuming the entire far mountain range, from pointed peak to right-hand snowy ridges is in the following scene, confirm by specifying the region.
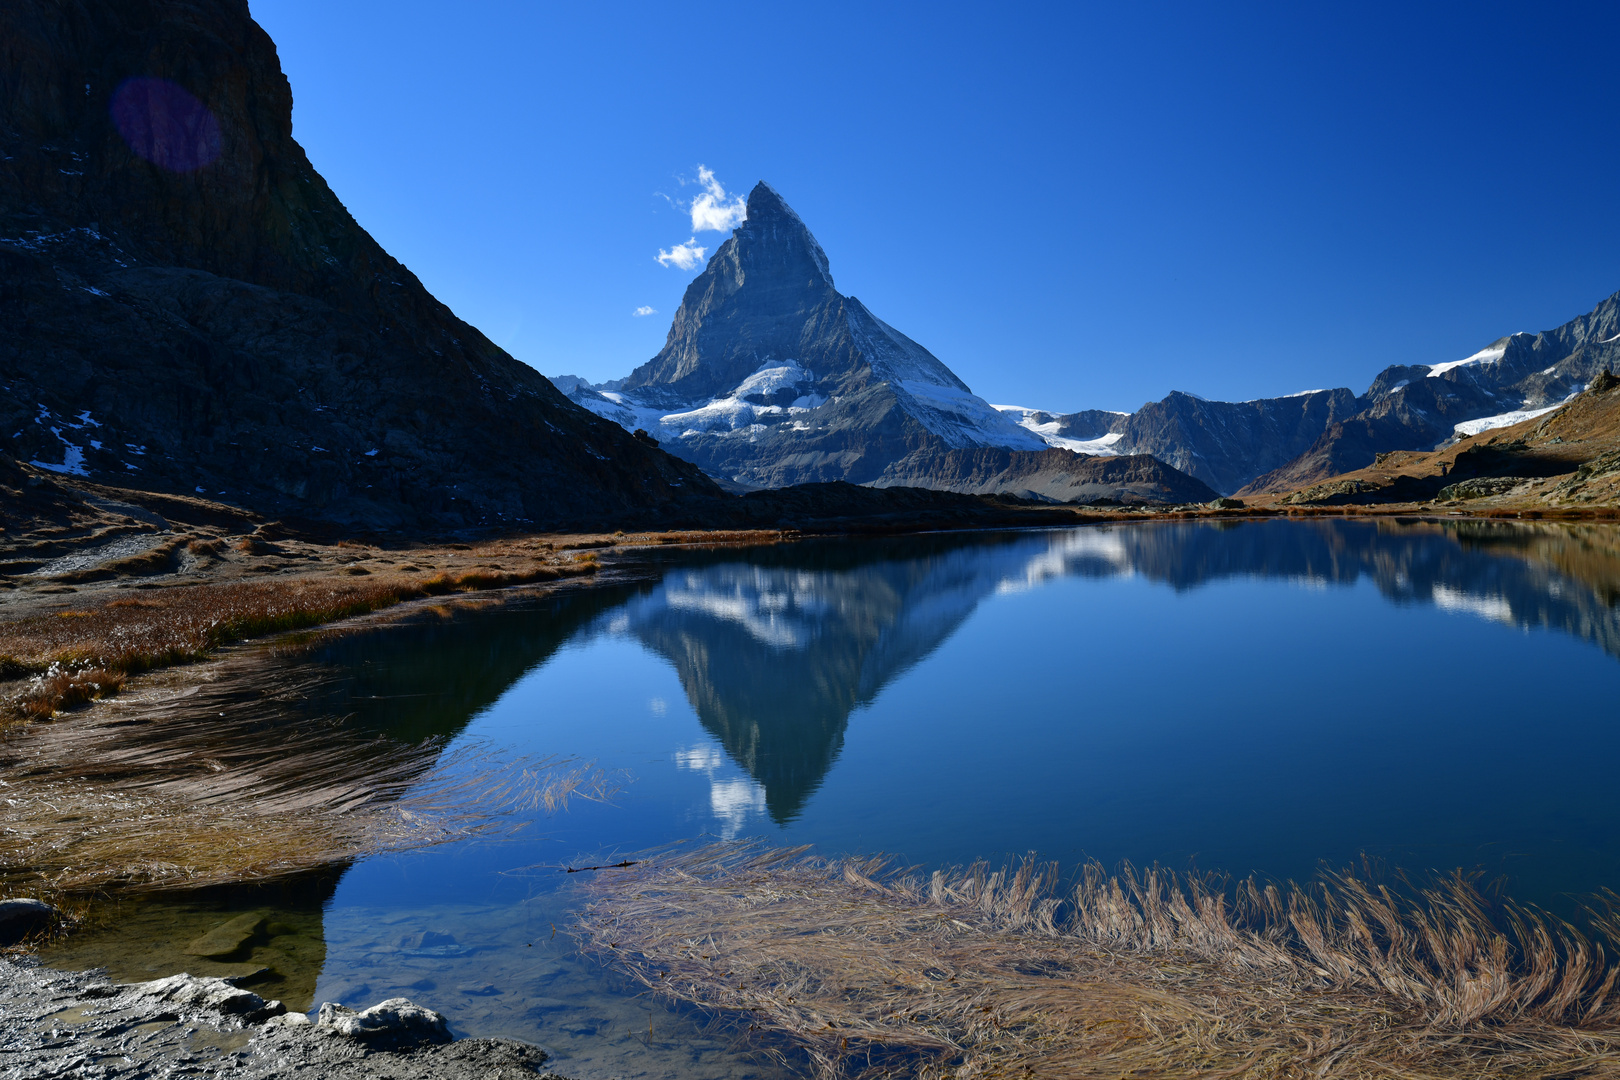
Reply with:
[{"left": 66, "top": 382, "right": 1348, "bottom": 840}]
[{"left": 554, "top": 181, "right": 1620, "bottom": 502}]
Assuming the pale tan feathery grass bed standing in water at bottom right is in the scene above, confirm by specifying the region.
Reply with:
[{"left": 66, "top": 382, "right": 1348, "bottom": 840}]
[{"left": 578, "top": 844, "right": 1620, "bottom": 1080}]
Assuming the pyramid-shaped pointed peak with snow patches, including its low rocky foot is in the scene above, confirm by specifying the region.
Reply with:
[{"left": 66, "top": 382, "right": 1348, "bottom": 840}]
[{"left": 557, "top": 181, "right": 1213, "bottom": 502}]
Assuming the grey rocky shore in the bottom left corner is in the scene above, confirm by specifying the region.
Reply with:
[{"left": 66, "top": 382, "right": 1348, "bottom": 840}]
[{"left": 0, "top": 957, "right": 564, "bottom": 1080}]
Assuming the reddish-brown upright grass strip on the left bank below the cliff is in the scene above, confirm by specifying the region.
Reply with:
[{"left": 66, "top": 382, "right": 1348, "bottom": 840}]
[{"left": 0, "top": 560, "right": 599, "bottom": 719}]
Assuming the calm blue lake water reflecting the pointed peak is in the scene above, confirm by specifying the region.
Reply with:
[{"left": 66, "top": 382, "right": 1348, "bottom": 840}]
[{"left": 44, "top": 520, "right": 1620, "bottom": 1077}]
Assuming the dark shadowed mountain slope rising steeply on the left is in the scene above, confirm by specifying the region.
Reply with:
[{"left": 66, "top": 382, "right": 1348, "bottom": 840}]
[{"left": 0, "top": 0, "right": 714, "bottom": 526}]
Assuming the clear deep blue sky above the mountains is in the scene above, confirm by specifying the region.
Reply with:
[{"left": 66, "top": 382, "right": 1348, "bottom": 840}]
[{"left": 251, "top": 0, "right": 1620, "bottom": 411}]
